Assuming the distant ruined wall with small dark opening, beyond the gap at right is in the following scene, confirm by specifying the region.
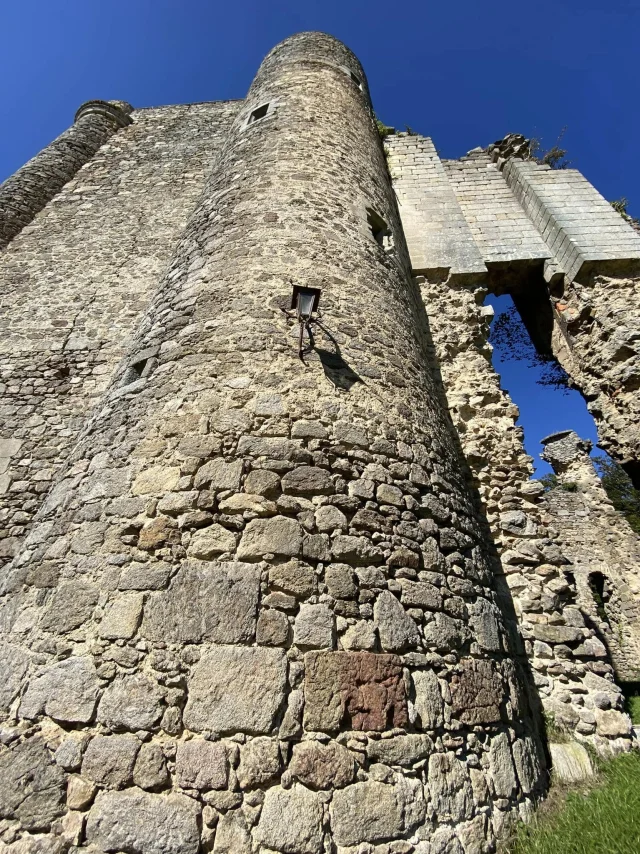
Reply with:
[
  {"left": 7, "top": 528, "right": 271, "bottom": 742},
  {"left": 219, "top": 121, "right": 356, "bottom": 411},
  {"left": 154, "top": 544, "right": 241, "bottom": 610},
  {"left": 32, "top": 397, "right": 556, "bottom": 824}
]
[{"left": 543, "top": 431, "right": 640, "bottom": 682}]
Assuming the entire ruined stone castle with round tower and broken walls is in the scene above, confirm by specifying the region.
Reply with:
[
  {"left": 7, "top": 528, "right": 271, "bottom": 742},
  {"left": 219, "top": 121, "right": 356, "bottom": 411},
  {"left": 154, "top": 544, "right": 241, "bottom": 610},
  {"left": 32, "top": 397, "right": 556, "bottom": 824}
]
[{"left": 0, "top": 33, "right": 640, "bottom": 854}]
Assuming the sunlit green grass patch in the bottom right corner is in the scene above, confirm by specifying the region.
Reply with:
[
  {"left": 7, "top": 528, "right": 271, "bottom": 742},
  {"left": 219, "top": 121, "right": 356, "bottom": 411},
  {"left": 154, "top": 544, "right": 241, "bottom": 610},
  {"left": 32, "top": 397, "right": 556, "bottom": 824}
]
[{"left": 502, "top": 751, "right": 640, "bottom": 854}]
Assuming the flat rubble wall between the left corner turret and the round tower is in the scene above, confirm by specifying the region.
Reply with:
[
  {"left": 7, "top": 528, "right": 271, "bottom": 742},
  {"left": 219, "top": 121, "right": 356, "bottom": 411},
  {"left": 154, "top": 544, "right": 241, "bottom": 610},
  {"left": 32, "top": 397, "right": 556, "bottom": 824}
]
[{"left": 0, "top": 102, "right": 239, "bottom": 563}]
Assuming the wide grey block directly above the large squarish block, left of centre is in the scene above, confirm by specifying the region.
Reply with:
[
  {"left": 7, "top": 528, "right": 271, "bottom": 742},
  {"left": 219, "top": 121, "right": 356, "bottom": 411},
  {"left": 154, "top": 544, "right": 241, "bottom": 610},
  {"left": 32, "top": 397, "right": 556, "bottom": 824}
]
[{"left": 142, "top": 561, "right": 260, "bottom": 643}]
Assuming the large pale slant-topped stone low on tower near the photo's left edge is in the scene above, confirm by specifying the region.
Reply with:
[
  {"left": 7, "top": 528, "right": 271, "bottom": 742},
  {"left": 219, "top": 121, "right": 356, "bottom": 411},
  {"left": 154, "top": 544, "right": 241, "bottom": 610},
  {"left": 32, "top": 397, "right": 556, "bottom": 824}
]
[{"left": 19, "top": 656, "right": 98, "bottom": 724}]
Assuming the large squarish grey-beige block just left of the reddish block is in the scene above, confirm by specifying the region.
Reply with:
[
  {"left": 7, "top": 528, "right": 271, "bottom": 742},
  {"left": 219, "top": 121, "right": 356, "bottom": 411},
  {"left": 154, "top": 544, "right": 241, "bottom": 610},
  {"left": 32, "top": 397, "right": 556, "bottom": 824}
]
[{"left": 184, "top": 646, "right": 287, "bottom": 733}]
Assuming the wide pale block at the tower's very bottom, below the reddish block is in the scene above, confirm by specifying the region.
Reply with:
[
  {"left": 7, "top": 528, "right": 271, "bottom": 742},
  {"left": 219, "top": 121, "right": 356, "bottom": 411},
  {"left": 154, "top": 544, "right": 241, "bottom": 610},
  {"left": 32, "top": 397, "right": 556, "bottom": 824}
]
[{"left": 330, "top": 779, "right": 426, "bottom": 845}]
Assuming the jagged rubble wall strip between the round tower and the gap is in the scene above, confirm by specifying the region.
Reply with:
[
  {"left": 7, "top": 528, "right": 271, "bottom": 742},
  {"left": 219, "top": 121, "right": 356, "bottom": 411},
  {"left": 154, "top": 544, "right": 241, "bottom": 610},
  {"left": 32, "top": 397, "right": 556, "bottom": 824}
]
[{"left": 419, "top": 278, "right": 630, "bottom": 755}]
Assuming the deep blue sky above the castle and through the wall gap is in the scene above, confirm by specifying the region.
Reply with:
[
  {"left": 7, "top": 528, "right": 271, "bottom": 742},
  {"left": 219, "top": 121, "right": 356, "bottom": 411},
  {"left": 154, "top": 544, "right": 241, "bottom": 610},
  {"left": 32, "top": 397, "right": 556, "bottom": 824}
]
[{"left": 0, "top": 0, "right": 640, "bottom": 474}]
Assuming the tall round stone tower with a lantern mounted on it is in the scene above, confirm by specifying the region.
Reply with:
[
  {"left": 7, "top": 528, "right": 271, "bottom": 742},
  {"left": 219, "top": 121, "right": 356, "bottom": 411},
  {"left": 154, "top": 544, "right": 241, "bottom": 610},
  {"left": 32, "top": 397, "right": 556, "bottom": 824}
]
[{"left": 0, "top": 33, "right": 542, "bottom": 854}]
